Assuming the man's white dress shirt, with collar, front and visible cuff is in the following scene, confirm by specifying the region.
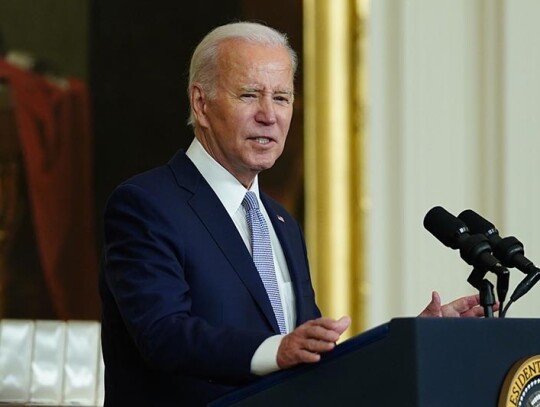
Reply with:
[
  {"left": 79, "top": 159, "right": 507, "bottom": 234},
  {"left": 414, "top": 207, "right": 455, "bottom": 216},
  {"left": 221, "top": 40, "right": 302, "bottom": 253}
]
[{"left": 186, "top": 138, "right": 296, "bottom": 375}]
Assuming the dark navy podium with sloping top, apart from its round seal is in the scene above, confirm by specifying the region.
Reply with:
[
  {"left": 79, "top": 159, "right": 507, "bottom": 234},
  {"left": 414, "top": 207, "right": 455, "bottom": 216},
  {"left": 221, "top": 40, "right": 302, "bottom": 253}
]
[{"left": 208, "top": 318, "right": 540, "bottom": 407}]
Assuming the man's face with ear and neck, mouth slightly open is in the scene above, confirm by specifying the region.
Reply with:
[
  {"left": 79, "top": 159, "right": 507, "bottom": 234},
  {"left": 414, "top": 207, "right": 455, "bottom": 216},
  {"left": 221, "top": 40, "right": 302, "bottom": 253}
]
[{"left": 192, "top": 40, "right": 293, "bottom": 187}]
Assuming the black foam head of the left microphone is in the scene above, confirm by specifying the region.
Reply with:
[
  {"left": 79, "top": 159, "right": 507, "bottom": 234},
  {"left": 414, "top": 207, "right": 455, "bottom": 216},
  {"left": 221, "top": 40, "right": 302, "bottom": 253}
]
[{"left": 424, "top": 206, "right": 469, "bottom": 249}]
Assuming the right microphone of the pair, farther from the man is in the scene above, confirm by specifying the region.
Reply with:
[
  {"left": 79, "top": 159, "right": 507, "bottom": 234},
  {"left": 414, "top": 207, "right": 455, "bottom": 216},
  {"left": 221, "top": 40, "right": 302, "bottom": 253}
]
[{"left": 458, "top": 209, "right": 540, "bottom": 302}]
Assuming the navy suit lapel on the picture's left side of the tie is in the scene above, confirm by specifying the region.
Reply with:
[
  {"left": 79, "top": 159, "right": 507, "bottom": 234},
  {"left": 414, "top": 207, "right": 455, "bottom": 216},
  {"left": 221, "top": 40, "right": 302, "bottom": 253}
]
[{"left": 169, "top": 151, "right": 279, "bottom": 333}]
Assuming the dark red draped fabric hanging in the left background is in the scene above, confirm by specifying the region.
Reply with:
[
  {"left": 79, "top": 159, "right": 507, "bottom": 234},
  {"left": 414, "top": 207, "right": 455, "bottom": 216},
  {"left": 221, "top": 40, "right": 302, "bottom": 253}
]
[{"left": 0, "top": 58, "right": 99, "bottom": 319}]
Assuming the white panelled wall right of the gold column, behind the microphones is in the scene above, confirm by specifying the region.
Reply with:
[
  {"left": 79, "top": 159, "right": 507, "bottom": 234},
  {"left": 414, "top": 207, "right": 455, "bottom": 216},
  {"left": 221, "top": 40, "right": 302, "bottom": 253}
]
[{"left": 366, "top": 0, "right": 540, "bottom": 326}]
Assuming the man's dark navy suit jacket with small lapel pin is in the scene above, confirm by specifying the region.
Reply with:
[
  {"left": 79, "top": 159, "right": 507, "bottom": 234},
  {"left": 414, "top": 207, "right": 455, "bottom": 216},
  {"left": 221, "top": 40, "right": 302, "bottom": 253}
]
[{"left": 100, "top": 151, "right": 320, "bottom": 406}]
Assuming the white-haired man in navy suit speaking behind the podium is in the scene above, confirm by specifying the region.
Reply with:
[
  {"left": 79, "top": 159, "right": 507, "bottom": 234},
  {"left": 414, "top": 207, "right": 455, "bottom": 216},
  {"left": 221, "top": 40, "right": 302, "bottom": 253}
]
[{"left": 100, "top": 23, "right": 488, "bottom": 406}]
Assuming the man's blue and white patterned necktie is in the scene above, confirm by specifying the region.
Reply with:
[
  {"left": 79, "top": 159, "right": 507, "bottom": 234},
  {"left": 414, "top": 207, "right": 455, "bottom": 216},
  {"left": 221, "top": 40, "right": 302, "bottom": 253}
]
[{"left": 242, "top": 191, "right": 287, "bottom": 334}]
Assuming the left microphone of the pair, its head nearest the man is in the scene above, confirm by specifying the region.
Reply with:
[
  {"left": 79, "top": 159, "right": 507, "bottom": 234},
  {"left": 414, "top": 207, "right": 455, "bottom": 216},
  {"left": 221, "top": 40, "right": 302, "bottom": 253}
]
[{"left": 424, "top": 206, "right": 508, "bottom": 275}]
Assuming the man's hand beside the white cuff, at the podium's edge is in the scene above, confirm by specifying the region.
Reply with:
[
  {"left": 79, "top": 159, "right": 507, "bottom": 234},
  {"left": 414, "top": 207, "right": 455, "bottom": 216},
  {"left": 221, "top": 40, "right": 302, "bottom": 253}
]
[{"left": 277, "top": 317, "right": 351, "bottom": 369}]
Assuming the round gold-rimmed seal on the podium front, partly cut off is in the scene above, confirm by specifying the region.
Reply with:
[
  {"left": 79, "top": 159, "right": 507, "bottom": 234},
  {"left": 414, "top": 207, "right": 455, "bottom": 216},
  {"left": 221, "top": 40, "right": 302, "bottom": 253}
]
[{"left": 498, "top": 355, "right": 540, "bottom": 407}]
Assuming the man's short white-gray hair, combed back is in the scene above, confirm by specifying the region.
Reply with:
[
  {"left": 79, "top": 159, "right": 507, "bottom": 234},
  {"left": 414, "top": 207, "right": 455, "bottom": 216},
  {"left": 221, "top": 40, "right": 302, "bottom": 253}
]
[{"left": 187, "top": 22, "right": 298, "bottom": 126}]
